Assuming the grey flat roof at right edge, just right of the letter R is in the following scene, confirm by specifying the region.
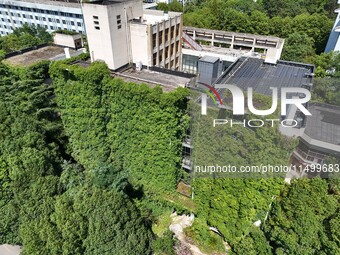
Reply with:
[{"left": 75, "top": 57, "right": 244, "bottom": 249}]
[{"left": 305, "top": 103, "right": 340, "bottom": 145}]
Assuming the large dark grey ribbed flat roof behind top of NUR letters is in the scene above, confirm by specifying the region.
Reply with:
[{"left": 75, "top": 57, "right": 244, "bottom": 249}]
[{"left": 216, "top": 57, "right": 314, "bottom": 96}]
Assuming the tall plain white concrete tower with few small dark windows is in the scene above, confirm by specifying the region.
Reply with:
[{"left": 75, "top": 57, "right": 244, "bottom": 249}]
[{"left": 83, "top": 1, "right": 143, "bottom": 70}]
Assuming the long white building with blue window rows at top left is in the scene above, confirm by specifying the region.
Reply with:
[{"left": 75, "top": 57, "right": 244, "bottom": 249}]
[{"left": 0, "top": 0, "right": 85, "bottom": 36}]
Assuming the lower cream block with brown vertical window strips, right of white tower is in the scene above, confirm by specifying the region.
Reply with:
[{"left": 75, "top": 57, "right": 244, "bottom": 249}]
[{"left": 130, "top": 10, "right": 182, "bottom": 70}]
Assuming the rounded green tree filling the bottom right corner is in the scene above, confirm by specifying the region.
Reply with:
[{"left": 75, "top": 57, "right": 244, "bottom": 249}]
[{"left": 265, "top": 179, "right": 340, "bottom": 255}]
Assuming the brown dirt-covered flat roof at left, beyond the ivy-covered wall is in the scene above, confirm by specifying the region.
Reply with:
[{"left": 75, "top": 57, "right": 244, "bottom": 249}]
[{"left": 4, "top": 46, "right": 73, "bottom": 66}]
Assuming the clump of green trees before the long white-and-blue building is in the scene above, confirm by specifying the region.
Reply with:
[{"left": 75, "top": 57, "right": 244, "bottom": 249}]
[{"left": 0, "top": 24, "right": 52, "bottom": 53}]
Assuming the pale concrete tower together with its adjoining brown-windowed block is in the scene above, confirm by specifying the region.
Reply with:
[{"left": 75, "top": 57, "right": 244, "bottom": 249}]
[{"left": 82, "top": 0, "right": 182, "bottom": 70}]
